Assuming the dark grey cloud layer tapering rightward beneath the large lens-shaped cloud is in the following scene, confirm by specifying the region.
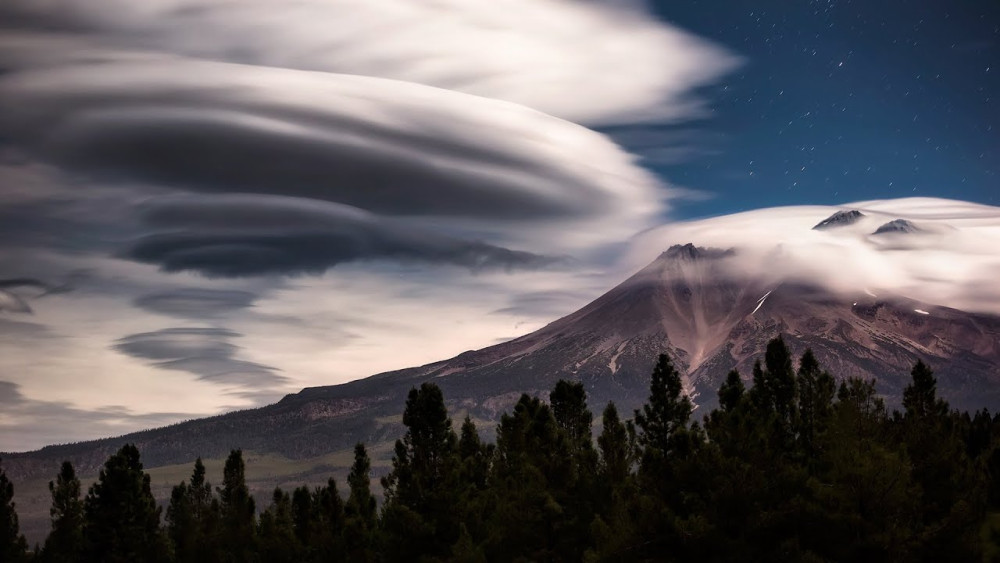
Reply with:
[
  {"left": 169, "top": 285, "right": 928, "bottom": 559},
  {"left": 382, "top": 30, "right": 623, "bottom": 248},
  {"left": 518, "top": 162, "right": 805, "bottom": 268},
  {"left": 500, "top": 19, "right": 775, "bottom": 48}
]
[{"left": 123, "top": 195, "right": 563, "bottom": 277}]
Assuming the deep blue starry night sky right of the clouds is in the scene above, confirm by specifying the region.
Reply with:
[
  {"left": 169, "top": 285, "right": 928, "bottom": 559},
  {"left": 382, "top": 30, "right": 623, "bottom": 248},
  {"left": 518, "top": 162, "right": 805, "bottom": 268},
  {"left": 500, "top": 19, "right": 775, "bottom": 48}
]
[{"left": 611, "top": 0, "right": 1000, "bottom": 217}]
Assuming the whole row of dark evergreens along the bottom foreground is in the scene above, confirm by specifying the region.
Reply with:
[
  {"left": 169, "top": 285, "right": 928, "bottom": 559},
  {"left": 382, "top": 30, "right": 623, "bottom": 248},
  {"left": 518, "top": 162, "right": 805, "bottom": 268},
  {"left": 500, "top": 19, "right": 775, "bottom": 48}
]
[{"left": 0, "top": 339, "right": 1000, "bottom": 562}]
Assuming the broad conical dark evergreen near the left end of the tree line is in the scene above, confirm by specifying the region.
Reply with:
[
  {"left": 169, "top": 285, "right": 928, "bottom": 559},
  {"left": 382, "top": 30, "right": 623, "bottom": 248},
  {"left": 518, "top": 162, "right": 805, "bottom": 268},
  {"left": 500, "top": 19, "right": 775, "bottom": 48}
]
[{"left": 83, "top": 444, "right": 169, "bottom": 563}]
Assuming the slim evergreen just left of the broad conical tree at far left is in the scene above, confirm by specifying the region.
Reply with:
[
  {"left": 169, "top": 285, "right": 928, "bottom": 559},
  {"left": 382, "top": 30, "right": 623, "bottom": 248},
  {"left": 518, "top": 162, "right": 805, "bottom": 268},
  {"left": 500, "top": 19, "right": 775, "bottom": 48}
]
[{"left": 44, "top": 461, "right": 83, "bottom": 563}]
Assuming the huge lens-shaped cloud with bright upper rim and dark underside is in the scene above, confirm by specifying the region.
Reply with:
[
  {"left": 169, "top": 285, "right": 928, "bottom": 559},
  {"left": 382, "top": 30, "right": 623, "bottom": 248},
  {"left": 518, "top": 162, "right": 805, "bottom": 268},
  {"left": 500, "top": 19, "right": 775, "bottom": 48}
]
[{"left": 0, "top": 57, "right": 657, "bottom": 221}]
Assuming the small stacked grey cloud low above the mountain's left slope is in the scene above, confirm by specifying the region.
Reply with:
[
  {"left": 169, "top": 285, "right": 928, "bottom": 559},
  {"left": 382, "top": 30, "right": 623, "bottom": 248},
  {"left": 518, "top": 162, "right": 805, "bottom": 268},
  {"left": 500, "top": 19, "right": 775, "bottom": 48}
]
[{"left": 114, "top": 328, "right": 286, "bottom": 388}]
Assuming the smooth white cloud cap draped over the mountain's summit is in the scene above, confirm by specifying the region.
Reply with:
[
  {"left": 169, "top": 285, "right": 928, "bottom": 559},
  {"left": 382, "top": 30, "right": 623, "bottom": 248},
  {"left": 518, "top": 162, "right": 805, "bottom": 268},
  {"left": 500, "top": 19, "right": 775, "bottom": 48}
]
[{"left": 628, "top": 198, "right": 1000, "bottom": 314}]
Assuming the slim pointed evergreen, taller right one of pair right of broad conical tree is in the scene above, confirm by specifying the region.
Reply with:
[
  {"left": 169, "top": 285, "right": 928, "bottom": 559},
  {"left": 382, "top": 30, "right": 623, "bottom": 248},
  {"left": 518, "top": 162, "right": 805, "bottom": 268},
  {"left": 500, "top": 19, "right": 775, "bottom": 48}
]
[{"left": 219, "top": 450, "right": 256, "bottom": 561}]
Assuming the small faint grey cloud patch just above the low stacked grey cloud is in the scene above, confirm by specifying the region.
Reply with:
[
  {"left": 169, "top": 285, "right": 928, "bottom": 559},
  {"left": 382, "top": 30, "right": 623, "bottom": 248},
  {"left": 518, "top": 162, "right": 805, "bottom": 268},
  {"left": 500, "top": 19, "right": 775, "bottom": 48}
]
[{"left": 133, "top": 287, "right": 257, "bottom": 319}]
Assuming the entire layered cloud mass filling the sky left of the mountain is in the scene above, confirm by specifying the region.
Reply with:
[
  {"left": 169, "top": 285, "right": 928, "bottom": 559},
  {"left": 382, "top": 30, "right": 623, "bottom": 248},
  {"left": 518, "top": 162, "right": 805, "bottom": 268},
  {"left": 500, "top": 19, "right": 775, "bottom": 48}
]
[{"left": 0, "top": 0, "right": 739, "bottom": 450}]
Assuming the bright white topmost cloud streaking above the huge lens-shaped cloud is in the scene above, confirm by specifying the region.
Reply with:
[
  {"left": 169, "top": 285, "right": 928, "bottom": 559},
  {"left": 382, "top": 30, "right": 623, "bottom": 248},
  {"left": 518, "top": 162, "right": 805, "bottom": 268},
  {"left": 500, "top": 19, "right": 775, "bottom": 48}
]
[{"left": 0, "top": 0, "right": 738, "bottom": 124}]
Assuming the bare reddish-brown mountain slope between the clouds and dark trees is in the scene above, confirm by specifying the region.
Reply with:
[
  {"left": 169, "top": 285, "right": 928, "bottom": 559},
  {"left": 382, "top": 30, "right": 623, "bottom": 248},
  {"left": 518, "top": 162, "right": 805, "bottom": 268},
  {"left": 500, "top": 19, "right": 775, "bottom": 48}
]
[{"left": 4, "top": 245, "right": 1000, "bottom": 478}]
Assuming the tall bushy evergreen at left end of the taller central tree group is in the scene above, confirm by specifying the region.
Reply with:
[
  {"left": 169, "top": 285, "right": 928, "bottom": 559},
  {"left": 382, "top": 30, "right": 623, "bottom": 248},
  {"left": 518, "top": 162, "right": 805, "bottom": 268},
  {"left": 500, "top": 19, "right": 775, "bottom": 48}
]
[{"left": 382, "top": 383, "right": 459, "bottom": 560}]
